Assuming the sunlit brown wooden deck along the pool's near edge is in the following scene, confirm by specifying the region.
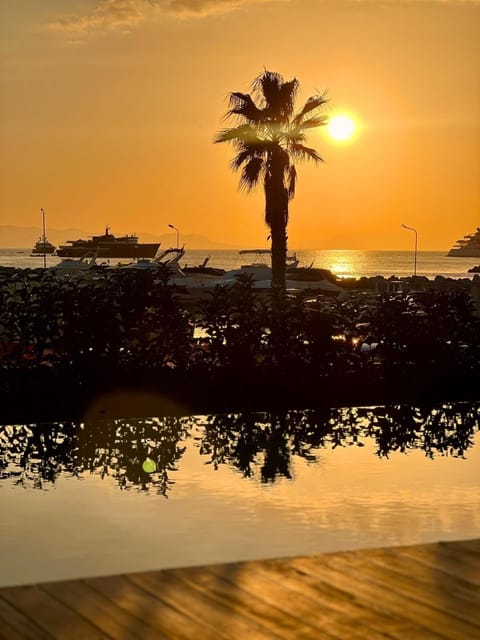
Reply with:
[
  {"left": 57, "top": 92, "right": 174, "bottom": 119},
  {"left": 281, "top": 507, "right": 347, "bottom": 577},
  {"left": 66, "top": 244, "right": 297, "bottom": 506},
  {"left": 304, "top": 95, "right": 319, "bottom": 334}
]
[{"left": 0, "top": 540, "right": 480, "bottom": 640}]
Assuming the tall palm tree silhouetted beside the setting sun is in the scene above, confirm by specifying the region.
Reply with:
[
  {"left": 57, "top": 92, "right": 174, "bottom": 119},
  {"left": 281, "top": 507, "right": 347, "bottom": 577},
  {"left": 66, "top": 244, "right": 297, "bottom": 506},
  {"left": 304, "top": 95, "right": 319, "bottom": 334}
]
[{"left": 214, "top": 70, "right": 327, "bottom": 289}]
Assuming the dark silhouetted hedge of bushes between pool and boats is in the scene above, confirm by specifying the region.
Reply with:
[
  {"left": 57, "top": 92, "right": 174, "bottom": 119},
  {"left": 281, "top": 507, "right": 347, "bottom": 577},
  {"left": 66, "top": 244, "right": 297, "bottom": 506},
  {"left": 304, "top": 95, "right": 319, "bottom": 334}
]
[{"left": 0, "top": 269, "right": 480, "bottom": 421}]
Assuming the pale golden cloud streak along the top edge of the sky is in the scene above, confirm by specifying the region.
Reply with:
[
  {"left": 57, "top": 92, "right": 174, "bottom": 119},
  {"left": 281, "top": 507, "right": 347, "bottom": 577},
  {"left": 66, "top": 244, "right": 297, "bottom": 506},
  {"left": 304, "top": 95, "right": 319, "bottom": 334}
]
[{"left": 48, "top": 0, "right": 480, "bottom": 39}]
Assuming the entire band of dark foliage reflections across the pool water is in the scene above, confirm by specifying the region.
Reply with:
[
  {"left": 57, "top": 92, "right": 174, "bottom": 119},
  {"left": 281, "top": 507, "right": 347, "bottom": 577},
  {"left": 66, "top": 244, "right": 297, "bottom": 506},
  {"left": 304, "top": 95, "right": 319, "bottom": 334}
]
[{"left": 0, "top": 403, "right": 480, "bottom": 496}]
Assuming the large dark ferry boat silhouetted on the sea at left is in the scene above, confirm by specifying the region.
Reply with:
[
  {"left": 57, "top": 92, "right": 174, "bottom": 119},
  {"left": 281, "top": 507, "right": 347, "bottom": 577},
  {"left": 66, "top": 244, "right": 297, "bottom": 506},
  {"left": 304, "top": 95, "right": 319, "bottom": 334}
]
[{"left": 56, "top": 226, "right": 160, "bottom": 258}]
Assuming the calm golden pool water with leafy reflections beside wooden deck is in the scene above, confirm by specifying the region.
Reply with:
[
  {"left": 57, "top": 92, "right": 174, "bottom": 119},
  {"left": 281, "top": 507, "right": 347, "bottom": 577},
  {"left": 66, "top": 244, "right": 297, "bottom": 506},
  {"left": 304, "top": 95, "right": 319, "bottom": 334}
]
[{"left": 0, "top": 404, "right": 480, "bottom": 585}]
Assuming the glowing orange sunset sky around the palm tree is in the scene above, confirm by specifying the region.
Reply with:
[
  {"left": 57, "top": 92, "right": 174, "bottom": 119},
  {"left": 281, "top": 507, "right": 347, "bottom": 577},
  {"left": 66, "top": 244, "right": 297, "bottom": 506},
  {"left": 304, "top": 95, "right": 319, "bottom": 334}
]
[{"left": 0, "top": 0, "right": 480, "bottom": 250}]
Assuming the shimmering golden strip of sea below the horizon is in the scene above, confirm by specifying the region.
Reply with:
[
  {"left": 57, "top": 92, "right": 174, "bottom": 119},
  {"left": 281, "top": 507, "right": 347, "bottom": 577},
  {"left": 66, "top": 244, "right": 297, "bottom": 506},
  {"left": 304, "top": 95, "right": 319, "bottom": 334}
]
[{"left": 0, "top": 248, "right": 480, "bottom": 278}]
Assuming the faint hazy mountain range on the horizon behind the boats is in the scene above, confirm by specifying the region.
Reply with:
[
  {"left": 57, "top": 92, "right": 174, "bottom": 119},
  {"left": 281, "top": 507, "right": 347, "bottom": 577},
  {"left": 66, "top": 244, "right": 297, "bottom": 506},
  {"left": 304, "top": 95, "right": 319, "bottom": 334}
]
[{"left": 0, "top": 225, "right": 235, "bottom": 251}]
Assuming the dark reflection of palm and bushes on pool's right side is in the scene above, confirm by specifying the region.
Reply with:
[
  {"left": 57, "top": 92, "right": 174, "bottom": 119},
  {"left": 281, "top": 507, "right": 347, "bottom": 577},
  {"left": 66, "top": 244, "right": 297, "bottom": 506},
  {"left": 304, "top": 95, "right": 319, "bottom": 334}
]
[{"left": 200, "top": 404, "right": 480, "bottom": 482}]
